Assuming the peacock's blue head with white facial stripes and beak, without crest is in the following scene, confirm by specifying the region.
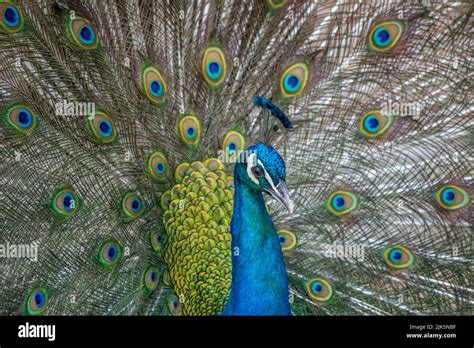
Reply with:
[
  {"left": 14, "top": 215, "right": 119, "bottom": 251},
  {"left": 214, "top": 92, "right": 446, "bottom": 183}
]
[{"left": 235, "top": 142, "right": 293, "bottom": 213}]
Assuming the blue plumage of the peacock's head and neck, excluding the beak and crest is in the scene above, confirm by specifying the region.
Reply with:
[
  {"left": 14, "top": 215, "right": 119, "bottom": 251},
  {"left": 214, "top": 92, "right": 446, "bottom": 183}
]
[{"left": 223, "top": 143, "right": 291, "bottom": 315}]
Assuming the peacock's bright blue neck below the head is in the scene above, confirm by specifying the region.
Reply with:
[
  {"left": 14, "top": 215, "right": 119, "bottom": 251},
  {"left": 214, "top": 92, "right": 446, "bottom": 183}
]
[{"left": 222, "top": 171, "right": 291, "bottom": 315}]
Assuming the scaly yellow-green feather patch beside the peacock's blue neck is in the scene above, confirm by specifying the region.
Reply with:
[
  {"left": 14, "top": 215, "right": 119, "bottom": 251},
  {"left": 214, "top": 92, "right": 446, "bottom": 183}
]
[{"left": 163, "top": 162, "right": 233, "bottom": 315}]
